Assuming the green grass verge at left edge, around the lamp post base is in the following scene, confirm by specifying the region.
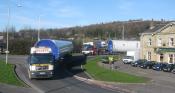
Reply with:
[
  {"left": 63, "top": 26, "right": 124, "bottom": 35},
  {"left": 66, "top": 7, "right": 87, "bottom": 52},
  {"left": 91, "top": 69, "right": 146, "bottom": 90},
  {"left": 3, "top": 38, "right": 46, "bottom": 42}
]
[{"left": 0, "top": 60, "right": 24, "bottom": 87}]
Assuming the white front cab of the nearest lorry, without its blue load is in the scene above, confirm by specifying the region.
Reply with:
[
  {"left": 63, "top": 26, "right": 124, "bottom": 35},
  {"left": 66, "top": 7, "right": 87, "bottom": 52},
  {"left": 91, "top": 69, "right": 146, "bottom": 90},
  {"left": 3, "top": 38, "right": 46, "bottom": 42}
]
[{"left": 28, "top": 47, "right": 54, "bottom": 79}]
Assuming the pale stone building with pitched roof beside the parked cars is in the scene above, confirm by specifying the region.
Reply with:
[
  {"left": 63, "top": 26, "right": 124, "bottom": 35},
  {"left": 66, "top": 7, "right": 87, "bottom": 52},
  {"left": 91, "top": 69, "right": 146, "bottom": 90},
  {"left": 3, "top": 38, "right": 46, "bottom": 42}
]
[{"left": 140, "top": 22, "right": 175, "bottom": 63}]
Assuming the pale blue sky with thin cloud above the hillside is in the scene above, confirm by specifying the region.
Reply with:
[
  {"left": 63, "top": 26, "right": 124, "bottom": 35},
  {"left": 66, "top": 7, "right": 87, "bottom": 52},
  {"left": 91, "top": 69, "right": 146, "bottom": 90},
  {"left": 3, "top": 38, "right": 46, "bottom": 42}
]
[{"left": 0, "top": 0, "right": 175, "bottom": 31}]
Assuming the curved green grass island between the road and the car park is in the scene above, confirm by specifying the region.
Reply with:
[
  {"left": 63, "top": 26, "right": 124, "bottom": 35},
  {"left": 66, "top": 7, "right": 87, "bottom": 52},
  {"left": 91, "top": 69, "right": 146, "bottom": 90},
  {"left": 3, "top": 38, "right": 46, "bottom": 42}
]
[{"left": 84, "top": 57, "right": 148, "bottom": 83}]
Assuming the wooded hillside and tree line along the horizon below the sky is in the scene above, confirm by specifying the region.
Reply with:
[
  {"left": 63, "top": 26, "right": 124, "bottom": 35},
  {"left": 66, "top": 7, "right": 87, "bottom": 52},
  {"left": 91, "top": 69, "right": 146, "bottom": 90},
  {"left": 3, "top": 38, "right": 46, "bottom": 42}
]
[{"left": 0, "top": 20, "right": 170, "bottom": 55}]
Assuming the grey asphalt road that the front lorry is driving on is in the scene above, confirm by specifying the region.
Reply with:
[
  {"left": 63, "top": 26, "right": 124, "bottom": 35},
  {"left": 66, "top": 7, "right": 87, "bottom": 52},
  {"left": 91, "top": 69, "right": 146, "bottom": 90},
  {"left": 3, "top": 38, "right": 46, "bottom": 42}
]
[{"left": 0, "top": 56, "right": 120, "bottom": 93}]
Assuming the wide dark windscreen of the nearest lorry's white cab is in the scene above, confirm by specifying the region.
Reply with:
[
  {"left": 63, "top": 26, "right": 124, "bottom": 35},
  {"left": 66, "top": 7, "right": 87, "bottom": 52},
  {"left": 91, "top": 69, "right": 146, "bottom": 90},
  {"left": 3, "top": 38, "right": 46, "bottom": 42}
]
[{"left": 31, "top": 54, "right": 53, "bottom": 64}]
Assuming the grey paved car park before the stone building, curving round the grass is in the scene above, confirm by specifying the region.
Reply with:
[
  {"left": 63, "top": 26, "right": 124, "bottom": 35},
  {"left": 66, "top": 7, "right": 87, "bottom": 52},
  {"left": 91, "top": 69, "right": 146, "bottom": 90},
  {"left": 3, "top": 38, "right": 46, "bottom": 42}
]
[{"left": 99, "top": 62, "right": 175, "bottom": 93}]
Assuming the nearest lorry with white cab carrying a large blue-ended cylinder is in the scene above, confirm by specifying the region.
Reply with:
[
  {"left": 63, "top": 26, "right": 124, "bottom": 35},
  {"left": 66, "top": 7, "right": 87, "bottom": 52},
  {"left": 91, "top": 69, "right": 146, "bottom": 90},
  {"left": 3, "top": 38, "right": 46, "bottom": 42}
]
[{"left": 28, "top": 39, "right": 73, "bottom": 79}]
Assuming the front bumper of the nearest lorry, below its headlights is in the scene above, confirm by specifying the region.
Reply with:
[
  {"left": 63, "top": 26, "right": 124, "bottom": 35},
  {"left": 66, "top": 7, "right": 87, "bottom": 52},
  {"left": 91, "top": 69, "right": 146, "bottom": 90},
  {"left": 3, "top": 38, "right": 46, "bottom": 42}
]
[{"left": 29, "top": 71, "right": 53, "bottom": 78}]
